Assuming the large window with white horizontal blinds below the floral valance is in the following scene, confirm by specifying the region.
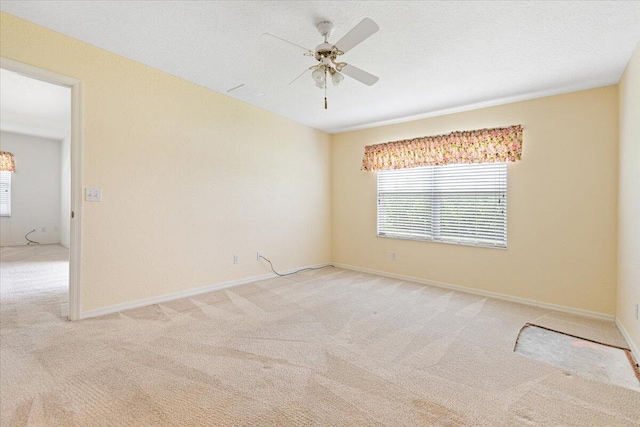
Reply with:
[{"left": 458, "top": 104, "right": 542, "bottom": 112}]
[{"left": 378, "top": 163, "right": 507, "bottom": 248}]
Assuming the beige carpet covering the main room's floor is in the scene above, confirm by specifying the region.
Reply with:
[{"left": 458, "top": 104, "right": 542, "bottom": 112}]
[{"left": 0, "top": 246, "right": 640, "bottom": 426}]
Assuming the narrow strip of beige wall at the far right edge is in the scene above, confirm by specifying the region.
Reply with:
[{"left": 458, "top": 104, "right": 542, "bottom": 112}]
[{"left": 616, "top": 44, "right": 640, "bottom": 350}]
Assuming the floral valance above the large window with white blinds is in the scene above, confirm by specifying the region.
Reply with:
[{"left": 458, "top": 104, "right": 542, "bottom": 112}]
[{"left": 362, "top": 125, "right": 522, "bottom": 171}]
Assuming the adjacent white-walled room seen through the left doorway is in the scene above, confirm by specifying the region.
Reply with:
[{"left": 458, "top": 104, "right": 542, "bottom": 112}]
[{"left": 0, "top": 69, "right": 71, "bottom": 319}]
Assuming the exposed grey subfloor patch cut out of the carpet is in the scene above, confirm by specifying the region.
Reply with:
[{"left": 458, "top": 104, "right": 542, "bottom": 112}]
[{"left": 514, "top": 324, "right": 640, "bottom": 391}]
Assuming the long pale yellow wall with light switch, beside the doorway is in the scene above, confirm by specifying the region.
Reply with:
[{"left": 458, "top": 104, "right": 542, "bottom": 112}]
[{"left": 0, "top": 13, "right": 331, "bottom": 311}]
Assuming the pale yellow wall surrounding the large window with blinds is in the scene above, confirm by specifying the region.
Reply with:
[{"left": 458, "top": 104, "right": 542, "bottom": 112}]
[{"left": 332, "top": 86, "right": 618, "bottom": 315}]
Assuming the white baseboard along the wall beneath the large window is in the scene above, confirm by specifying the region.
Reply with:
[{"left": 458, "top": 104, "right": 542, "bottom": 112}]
[{"left": 333, "top": 263, "right": 615, "bottom": 322}]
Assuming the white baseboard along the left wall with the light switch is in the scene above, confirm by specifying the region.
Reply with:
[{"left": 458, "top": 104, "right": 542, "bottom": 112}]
[{"left": 80, "top": 263, "right": 333, "bottom": 319}]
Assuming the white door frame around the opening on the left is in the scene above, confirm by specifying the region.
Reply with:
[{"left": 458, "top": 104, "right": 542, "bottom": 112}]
[{"left": 0, "top": 57, "right": 83, "bottom": 320}]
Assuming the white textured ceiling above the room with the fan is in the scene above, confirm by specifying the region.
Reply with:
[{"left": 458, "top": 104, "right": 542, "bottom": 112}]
[{"left": 0, "top": 0, "right": 640, "bottom": 133}]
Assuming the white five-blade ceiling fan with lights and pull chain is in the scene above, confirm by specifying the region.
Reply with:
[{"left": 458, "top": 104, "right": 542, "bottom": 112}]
[{"left": 263, "top": 18, "right": 379, "bottom": 110}]
